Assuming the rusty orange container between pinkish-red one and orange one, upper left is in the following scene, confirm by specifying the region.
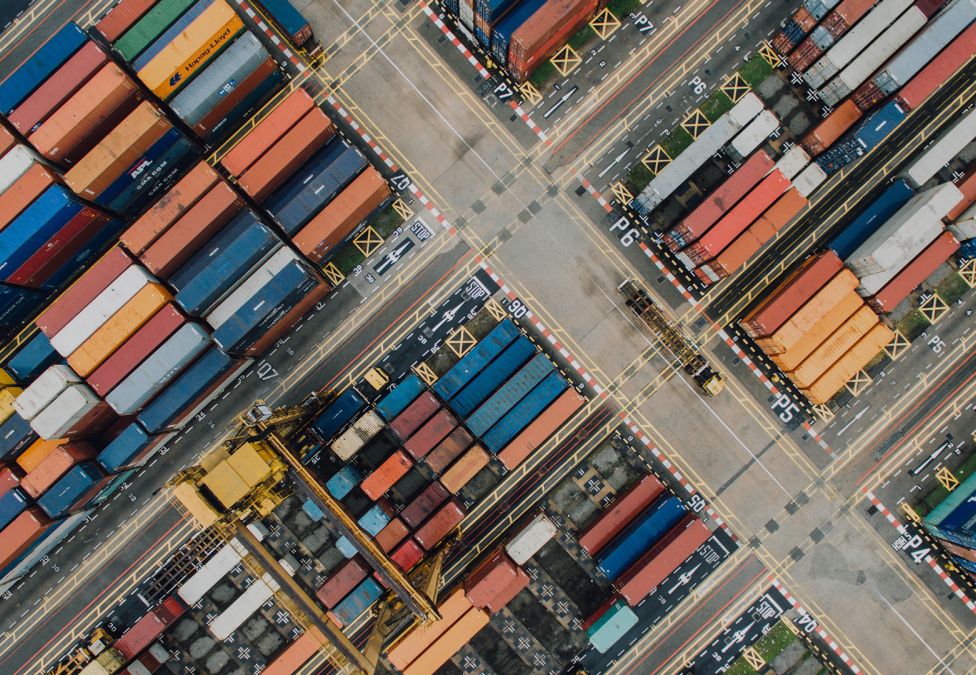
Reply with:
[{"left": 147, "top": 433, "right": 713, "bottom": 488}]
[{"left": 28, "top": 63, "right": 142, "bottom": 164}]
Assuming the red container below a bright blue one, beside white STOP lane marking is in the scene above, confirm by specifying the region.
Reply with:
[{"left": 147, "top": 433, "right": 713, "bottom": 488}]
[{"left": 617, "top": 513, "right": 712, "bottom": 607}]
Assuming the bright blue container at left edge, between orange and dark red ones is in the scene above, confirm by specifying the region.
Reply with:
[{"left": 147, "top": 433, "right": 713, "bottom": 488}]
[{"left": 0, "top": 185, "right": 82, "bottom": 279}]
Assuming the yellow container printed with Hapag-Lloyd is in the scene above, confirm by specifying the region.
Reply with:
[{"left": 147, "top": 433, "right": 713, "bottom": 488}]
[{"left": 139, "top": 0, "right": 244, "bottom": 100}]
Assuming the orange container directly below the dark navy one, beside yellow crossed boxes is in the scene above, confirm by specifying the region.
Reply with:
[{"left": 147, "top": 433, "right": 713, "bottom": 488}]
[{"left": 293, "top": 167, "right": 390, "bottom": 262}]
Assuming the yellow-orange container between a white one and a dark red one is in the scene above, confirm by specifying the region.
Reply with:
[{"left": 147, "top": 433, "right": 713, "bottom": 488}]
[{"left": 68, "top": 284, "right": 173, "bottom": 377}]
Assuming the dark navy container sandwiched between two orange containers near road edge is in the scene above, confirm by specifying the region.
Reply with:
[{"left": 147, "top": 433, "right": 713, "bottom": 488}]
[{"left": 265, "top": 138, "right": 366, "bottom": 235}]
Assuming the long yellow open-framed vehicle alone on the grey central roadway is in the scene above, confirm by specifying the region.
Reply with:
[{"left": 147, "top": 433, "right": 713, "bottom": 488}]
[{"left": 617, "top": 279, "right": 725, "bottom": 396}]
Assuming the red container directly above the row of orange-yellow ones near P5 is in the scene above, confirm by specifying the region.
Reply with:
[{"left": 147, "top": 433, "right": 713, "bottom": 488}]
[{"left": 739, "top": 251, "right": 843, "bottom": 338}]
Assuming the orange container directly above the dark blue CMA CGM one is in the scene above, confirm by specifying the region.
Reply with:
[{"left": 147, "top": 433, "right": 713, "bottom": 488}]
[{"left": 64, "top": 101, "right": 172, "bottom": 199}]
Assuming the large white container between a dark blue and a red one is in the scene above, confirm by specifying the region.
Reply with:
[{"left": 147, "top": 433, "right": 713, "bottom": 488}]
[{"left": 844, "top": 183, "right": 962, "bottom": 276}]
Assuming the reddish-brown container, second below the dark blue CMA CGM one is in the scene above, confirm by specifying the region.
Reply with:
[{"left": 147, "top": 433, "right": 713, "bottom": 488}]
[{"left": 139, "top": 182, "right": 244, "bottom": 279}]
